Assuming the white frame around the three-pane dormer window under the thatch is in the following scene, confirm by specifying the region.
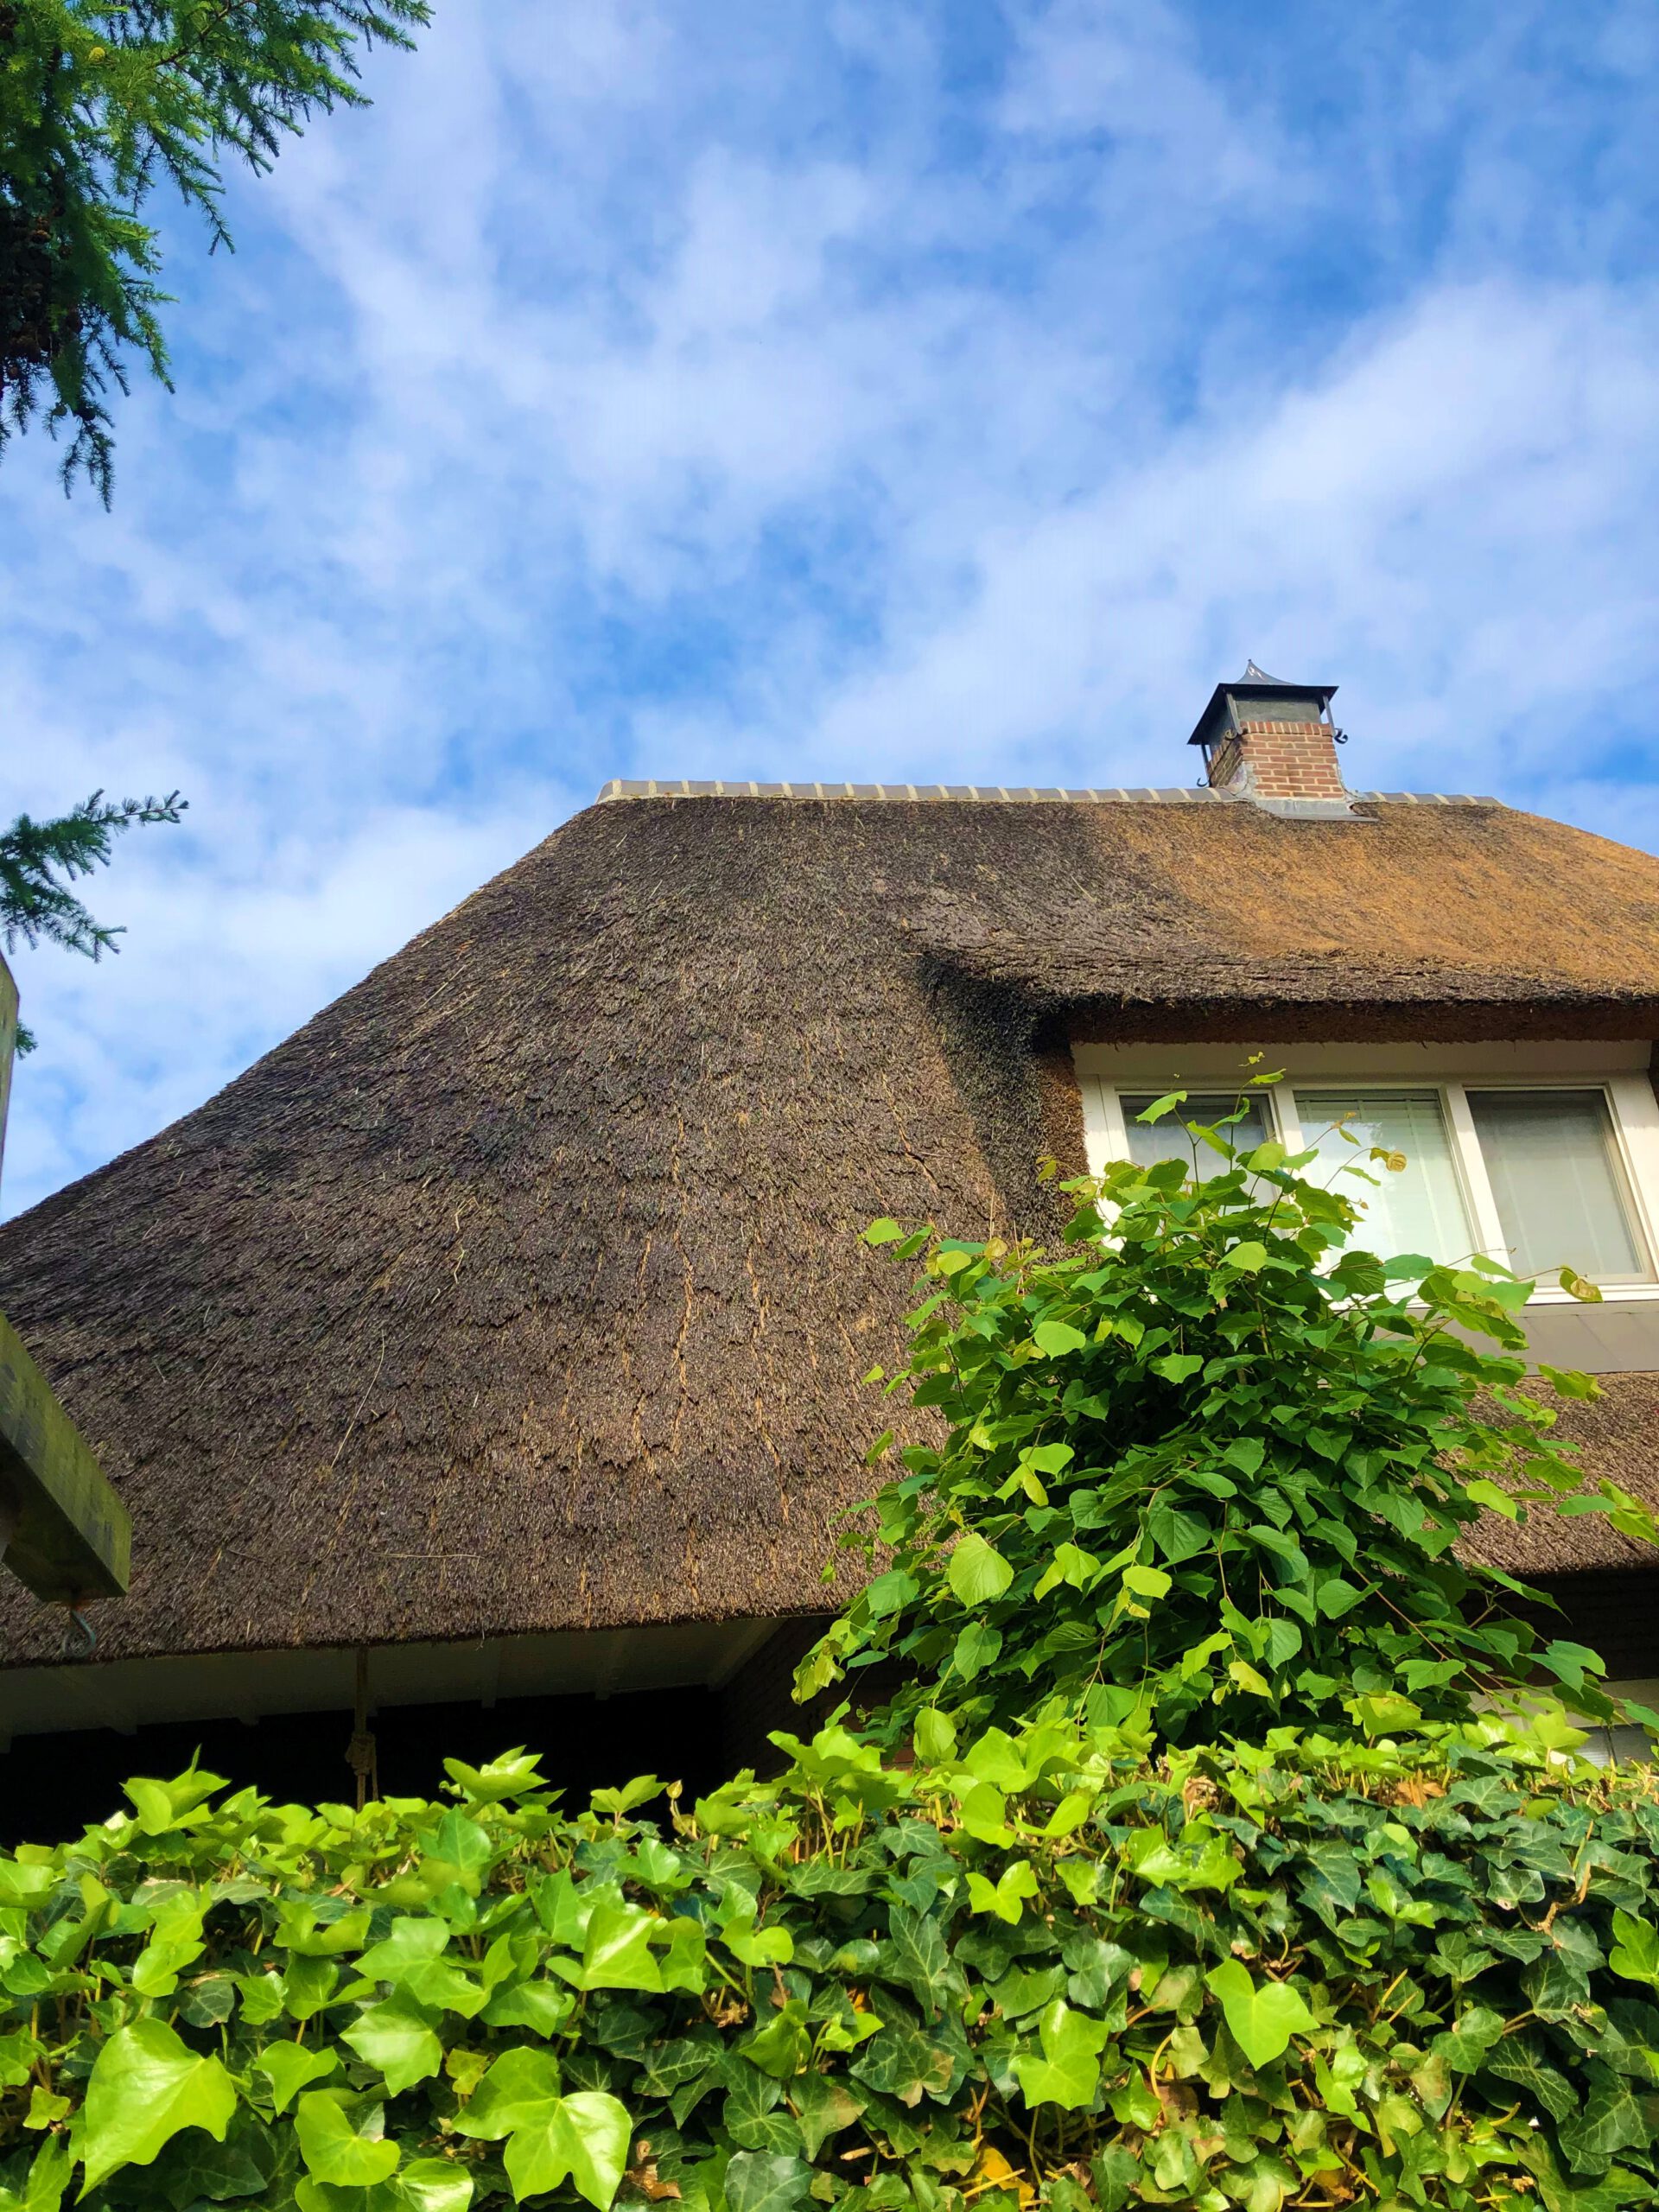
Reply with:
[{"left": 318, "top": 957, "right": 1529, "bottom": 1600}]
[{"left": 1073, "top": 1042, "right": 1659, "bottom": 1305}]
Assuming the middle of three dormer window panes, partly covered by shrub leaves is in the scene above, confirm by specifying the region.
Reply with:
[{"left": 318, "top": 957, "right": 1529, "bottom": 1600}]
[{"left": 1296, "top": 1090, "right": 1473, "bottom": 1259}]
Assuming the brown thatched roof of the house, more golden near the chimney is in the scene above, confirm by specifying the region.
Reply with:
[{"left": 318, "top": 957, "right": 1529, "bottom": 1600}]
[{"left": 0, "top": 794, "right": 1659, "bottom": 1663}]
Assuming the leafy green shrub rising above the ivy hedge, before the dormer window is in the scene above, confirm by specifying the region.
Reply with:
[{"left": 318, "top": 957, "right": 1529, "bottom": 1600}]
[{"left": 798, "top": 1106, "right": 1659, "bottom": 1743}]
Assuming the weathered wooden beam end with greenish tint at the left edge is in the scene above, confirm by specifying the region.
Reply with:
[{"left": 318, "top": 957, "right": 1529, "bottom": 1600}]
[{"left": 0, "top": 1314, "right": 133, "bottom": 1606}]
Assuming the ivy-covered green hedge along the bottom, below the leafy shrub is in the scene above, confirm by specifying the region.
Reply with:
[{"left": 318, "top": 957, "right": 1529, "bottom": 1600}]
[{"left": 0, "top": 1717, "right": 1659, "bottom": 2212}]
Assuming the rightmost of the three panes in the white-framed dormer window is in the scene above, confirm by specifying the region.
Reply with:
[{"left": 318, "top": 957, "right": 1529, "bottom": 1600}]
[{"left": 1469, "top": 1090, "right": 1648, "bottom": 1279}]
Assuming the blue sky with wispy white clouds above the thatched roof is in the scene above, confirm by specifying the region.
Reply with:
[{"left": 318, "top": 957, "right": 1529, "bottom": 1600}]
[{"left": 0, "top": 0, "right": 1659, "bottom": 1210}]
